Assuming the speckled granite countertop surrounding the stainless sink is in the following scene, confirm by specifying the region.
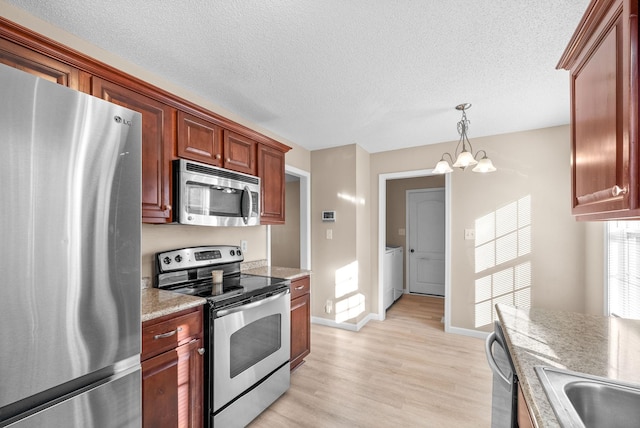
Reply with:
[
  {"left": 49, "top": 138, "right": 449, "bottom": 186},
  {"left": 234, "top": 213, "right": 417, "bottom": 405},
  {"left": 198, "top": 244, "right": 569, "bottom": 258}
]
[{"left": 496, "top": 304, "right": 640, "bottom": 428}]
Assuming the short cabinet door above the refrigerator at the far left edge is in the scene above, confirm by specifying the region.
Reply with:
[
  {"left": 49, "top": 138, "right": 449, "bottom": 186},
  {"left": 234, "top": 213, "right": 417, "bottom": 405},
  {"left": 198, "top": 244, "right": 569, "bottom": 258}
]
[{"left": 0, "top": 39, "right": 80, "bottom": 90}]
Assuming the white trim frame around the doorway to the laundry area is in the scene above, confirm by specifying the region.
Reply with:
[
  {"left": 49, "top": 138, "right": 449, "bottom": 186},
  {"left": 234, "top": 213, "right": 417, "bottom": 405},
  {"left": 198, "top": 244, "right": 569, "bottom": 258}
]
[{"left": 377, "top": 169, "right": 452, "bottom": 332}]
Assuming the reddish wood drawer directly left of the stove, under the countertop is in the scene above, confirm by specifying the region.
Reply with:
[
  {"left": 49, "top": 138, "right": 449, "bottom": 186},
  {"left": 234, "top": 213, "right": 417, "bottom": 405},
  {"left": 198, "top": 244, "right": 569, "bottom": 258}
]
[{"left": 141, "top": 308, "right": 202, "bottom": 361}]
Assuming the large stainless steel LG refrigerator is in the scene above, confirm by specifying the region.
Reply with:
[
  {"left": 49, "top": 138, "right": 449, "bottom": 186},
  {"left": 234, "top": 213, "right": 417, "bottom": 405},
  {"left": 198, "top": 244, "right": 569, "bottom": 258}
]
[{"left": 0, "top": 64, "right": 142, "bottom": 428}]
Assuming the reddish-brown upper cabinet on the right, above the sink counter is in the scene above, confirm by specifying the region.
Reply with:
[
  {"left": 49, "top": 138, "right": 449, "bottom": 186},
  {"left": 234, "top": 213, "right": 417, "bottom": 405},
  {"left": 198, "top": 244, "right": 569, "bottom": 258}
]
[{"left": 558, "top": 0, "right": 640, "bottom": 220}]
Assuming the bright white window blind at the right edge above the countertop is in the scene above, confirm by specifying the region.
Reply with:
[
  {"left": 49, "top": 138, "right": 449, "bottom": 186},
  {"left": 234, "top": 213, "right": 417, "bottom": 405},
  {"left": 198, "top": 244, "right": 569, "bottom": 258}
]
[{"left": 607, "top": 221, "right": 640, "bottom": 319}]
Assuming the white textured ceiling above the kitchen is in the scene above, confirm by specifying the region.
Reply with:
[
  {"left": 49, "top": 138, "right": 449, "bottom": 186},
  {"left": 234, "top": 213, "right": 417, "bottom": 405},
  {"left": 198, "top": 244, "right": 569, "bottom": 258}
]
[{"left": 6, "top": 0, "right": 589, "bottom": 153}]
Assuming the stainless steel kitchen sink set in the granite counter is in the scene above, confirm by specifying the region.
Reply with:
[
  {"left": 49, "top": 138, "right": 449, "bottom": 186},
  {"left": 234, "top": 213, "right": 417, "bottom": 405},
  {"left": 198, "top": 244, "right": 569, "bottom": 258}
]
[{"left": 535, "top": 366, "right": 640, "bottom": 428}]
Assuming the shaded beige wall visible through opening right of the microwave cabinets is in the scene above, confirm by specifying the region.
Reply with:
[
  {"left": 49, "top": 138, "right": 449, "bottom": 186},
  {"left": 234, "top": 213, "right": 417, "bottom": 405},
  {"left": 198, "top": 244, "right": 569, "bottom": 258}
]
[{"left": 271, "top": 180, "right": 300, "bottom": 268}]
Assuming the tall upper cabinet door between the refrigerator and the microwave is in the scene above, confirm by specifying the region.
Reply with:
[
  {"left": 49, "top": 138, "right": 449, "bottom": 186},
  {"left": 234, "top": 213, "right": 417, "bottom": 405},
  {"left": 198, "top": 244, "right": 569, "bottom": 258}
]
[{"left": 92, "top": 77, "right": 175, "bottom": 223}]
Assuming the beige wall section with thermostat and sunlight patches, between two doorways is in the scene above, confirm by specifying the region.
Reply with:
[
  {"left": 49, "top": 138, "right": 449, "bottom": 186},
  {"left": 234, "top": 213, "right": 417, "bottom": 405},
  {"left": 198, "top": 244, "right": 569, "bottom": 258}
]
[{"left": 311, "top": 145, "right": 374, "bottom": 322}]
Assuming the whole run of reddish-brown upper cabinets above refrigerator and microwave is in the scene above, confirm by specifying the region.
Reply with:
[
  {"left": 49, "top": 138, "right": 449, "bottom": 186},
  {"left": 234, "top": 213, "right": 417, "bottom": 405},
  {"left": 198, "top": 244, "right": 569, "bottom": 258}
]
[{"left": 0, "top": 16, "right": 291, "bottom": 224}]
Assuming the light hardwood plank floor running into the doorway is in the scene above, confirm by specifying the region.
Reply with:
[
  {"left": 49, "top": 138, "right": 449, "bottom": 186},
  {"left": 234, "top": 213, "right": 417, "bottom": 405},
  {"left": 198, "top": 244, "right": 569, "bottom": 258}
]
[{"left": 250, "top": 295, "right": 492, "bottom": 428}]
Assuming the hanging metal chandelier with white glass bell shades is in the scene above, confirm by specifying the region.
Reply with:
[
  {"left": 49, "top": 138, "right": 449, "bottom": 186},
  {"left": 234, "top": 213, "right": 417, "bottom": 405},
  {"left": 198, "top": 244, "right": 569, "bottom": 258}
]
[{"left": 433, "top": 103, "right": 496, "bottom": 174}]
